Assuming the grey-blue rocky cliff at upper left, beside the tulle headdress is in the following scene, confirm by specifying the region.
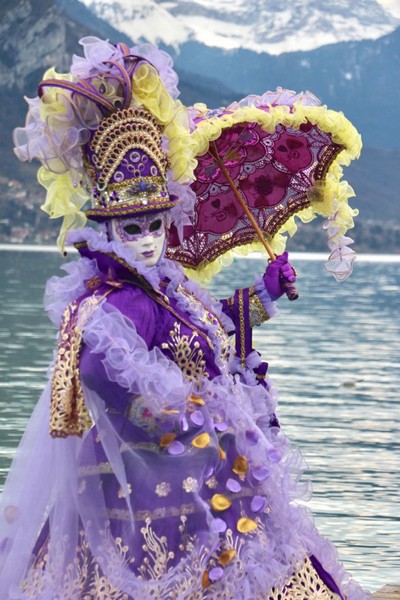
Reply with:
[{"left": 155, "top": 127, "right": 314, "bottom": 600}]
[{"left": 0, "top": 0, "right": 124, "bottom": 175}]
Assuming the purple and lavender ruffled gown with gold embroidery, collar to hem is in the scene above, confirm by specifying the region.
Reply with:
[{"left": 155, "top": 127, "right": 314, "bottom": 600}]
[{"left": 0, "top": 229, "right": 368, "bottom": 600}]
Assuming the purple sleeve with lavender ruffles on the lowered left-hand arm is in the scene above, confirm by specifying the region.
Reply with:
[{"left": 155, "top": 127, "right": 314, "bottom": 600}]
[{"left": 80, "top": 293, "right": 191, "bottom": 418}]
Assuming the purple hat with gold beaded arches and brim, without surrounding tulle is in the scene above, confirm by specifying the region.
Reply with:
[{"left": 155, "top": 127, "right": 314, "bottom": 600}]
[{"left": 84, "top": 107, "right": 178, "bottom": 221}]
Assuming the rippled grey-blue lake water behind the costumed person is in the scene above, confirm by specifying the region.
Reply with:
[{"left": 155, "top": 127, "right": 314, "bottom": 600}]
[{"left": 0, "top": 247, "right": 400, "bottom": 591}]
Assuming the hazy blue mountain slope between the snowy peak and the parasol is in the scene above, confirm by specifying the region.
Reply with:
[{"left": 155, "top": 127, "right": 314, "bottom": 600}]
[{"left": 167, "top": 28, "right": 400, "bottom": 149}]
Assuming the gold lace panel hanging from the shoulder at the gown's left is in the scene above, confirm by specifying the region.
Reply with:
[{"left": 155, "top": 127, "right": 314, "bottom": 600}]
[{"left": 50, "top": 289, "right": 112, "bottom": 438}]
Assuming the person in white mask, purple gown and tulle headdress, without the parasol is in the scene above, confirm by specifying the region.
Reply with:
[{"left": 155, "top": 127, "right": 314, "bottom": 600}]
[{"left": 0, "top": 38, "right": 367, "bottom": 600}]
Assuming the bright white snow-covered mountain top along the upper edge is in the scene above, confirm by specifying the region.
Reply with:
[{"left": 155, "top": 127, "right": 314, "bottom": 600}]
[{"left": 81, "top": 0, "right": 400, "bottom": 55}]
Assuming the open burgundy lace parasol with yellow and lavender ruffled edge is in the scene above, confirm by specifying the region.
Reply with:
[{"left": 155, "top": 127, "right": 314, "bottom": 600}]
[{"left": 168, "top": 88, "right": 361, "bottom": 282}]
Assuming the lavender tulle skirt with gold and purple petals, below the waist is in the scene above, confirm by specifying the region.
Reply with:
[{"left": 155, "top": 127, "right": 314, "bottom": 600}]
[{"left": 0, "top": 370, "right": 368, "bottom": 600}]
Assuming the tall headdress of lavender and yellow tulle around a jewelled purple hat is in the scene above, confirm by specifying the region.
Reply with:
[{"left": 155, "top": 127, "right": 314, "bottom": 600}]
[{"left": 14, "top": 37, "right": 195, "bottom": 249}]
